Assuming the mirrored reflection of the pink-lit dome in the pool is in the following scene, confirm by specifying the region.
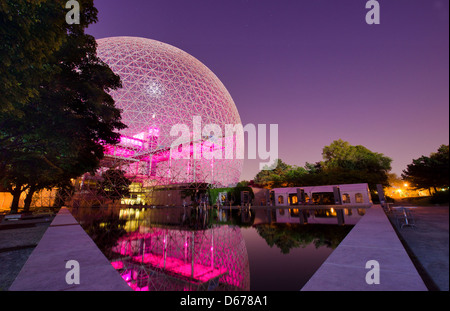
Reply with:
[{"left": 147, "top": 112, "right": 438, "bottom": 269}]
[{"left": 112, "top": 226, "right": 250, "bottom": 291}]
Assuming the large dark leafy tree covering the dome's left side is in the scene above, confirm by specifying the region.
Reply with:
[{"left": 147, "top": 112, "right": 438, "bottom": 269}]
[{"left": 0, "top": 0, "right": 125, "bottom": 213}]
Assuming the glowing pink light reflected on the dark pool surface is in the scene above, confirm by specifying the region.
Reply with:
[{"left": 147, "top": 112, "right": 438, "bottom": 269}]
[{"left": 113, "top": 227, "right": 249, "bottom": 290}]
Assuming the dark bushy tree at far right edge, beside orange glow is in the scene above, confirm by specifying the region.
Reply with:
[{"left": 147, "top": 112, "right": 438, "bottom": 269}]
[{"left": 402, "top": 145, "right": 449, "bottom": 193}]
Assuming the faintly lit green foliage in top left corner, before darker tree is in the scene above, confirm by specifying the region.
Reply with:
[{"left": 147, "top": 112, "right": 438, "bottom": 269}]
[{"left": 0, "top": 0, "right": 69, "bottom": 115}]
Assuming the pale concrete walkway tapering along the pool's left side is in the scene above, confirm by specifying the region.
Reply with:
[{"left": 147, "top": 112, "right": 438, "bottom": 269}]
[{"left": 9, "top": 208, "right": 131, "bottom": 291}]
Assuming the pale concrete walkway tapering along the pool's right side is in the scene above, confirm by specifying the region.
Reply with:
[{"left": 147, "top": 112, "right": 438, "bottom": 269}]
[{"left": 302, "top": 206, "right": 428, "bottom": 291}]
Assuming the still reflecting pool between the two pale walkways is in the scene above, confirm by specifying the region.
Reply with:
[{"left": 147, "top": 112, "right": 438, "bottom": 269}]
[{"left": 72, "top": 207, "right": 365, "bottom": 291}]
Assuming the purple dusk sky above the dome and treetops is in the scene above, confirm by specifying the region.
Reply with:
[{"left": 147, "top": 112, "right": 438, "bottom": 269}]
[{"left": 88, "top": 0, "right": 449, "bottom": 180}]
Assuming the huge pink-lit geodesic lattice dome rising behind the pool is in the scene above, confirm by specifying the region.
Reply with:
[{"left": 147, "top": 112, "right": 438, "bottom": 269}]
[{"left": 97, "top": 37, "right": 243, "bottom": 186}]
